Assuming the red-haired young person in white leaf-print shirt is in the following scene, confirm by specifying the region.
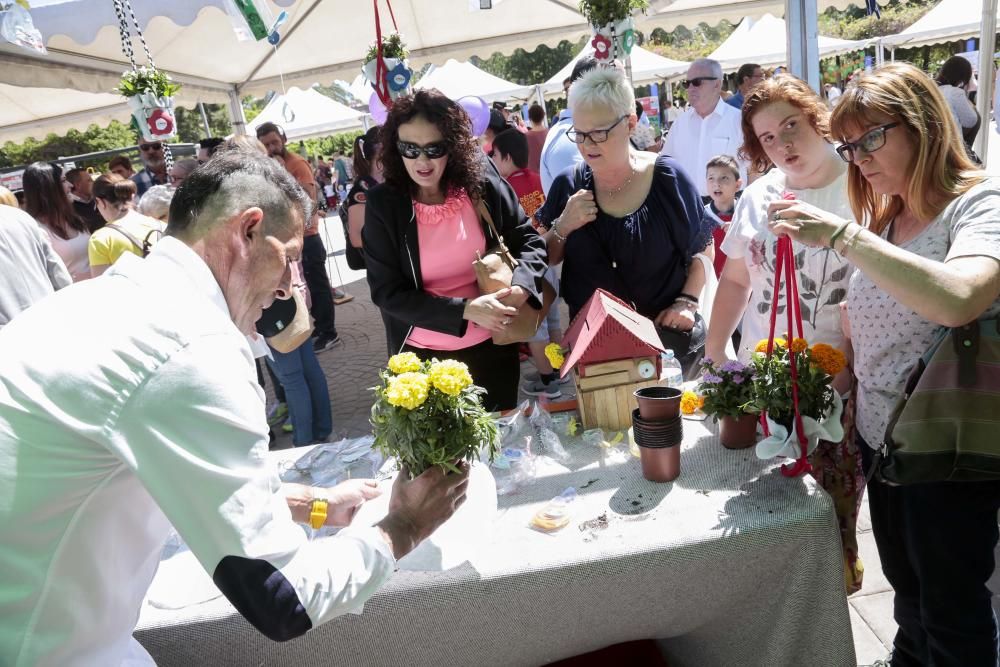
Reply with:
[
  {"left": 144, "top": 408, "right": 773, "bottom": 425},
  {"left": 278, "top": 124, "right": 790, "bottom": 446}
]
[{"left": 706, "top": 75, "right": 864, "bottom": 593}]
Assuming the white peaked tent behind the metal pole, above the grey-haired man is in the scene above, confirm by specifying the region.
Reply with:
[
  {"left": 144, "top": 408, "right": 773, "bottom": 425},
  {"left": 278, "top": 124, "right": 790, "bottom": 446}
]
[{"left": 708, "top": 14, "right": 871, "bottom": 72}]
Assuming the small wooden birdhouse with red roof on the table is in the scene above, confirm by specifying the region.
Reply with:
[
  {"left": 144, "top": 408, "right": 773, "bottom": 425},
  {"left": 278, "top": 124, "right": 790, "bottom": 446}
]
[{"left": 562, "top": 289, "right": 664, "bottom": 430}]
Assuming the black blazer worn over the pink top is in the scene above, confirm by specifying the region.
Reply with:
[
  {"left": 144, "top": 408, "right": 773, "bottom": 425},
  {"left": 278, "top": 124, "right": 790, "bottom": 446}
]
[{"left": 361, "top": 163, "right": 548, "bottom": 355}]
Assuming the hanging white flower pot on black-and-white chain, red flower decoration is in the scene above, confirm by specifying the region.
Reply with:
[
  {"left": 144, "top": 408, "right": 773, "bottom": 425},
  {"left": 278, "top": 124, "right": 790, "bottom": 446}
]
[{"left": 114, "top": 0, "right": 180, "bottom": 159}]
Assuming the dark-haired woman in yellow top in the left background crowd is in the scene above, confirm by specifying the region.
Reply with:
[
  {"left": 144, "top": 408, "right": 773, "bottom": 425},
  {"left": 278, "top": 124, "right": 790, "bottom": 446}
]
[{"left": 87, "top": 174, "right": 166, "bottom": 278}]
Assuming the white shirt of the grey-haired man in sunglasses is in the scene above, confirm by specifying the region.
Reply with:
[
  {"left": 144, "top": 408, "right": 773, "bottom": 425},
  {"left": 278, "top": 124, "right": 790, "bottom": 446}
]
[{"left": 660, "top": 99, "right": 748, "bottom": 197}]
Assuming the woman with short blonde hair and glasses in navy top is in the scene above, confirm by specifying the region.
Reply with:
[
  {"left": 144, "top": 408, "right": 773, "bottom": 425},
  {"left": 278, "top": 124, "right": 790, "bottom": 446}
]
[{"left": 537, "top": 67, "right": 716, "bottom": 374}]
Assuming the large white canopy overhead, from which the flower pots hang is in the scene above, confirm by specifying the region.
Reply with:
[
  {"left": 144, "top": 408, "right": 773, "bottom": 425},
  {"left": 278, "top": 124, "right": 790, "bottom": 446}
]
[{"left": 0, "top": 0, "right": 892, "bottom": 141}]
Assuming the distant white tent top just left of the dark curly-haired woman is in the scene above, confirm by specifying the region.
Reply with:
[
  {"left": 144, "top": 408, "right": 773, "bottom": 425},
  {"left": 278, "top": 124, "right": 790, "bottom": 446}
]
[{"left": 247, "top": 88, "right": 365, "bottom": 141}]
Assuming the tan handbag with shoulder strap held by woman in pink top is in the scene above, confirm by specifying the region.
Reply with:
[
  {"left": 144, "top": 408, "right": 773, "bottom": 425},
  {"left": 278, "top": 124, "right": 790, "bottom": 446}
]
[{"left": 472, "top": 200, "right": 556, "bottom": 345}]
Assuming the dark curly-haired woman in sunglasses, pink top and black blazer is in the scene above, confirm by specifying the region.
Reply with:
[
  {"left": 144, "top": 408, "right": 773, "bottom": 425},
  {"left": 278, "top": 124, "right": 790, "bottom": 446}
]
[{"left": 361, "top": 90, "right": 547, "bottom": 410}]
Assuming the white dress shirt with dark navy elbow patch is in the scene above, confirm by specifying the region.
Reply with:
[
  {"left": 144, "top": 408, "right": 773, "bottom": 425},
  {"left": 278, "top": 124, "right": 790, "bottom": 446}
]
[{"left": 0, "top": 237, "right": 395, "bottom": 667}]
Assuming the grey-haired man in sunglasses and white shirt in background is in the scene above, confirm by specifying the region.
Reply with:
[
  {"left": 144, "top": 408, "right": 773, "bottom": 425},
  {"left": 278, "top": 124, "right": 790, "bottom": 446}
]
[{"left": 660, "top": 58, "right": 748, "bottom": 197}]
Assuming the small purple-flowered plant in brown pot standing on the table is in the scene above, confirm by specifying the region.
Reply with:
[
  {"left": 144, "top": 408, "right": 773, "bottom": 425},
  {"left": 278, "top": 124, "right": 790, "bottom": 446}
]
[{"left": 698, "top": 359, "right": 760, "bottom": 449}]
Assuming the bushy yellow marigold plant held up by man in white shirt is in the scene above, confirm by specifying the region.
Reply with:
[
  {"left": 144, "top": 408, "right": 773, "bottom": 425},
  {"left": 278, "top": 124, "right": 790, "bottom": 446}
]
[{"left": 371, "top": 353, "right": 500, "bottom": 477}]
